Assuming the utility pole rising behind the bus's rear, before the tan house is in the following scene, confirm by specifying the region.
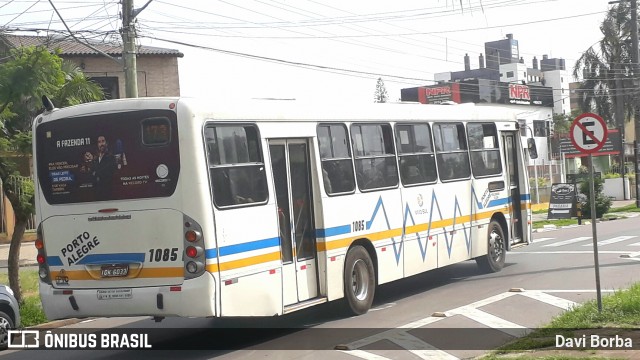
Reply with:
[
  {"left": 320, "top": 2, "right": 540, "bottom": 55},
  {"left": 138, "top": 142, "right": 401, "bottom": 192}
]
[{"left": 122, "top": 0, "right": 138, "bottom": 98}]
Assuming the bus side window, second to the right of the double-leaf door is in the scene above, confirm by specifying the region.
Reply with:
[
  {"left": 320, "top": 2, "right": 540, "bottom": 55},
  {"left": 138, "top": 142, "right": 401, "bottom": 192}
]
[{"left": 351, "top": 124, "right": 398, "bottom": 190}]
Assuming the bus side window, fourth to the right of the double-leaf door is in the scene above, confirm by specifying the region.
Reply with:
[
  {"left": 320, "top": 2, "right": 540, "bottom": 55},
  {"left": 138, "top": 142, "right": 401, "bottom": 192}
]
[{"left": 433, "top": 123, "right": 471, "bottom": 181}]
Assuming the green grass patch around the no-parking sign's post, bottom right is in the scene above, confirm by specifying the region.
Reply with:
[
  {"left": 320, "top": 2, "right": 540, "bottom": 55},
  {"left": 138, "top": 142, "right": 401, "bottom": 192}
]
[{"left": 484, "top": 283, "right": 640, "bottom": 359}]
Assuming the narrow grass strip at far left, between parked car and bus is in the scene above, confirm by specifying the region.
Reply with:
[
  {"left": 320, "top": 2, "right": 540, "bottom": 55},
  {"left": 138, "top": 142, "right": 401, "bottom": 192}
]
[{"left": 0, "top": 270, "right": 47, "bottom": 327}]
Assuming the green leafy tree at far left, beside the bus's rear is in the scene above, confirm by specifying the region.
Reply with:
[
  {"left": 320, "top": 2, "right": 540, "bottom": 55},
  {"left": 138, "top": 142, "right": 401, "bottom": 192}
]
[{"left": 0, "top": 47, "right": 104, "bottom": 302}]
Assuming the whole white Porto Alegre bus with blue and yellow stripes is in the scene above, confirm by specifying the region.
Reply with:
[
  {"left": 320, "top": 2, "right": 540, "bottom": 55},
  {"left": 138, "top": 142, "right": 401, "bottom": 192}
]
[{"left": 33, "top": 98, "right": 531, "bottom": 321}]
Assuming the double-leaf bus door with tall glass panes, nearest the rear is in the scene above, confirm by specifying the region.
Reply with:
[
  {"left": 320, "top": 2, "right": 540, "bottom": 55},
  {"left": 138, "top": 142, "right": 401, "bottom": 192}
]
[{"left": 269, "top": 139, "right": 318, "bottom": 306}]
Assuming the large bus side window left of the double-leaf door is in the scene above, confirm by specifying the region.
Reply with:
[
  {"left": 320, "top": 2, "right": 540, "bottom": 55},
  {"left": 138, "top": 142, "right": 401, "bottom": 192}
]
[{"left": 205, "top": 124, "right": 268, "bottom": 207}]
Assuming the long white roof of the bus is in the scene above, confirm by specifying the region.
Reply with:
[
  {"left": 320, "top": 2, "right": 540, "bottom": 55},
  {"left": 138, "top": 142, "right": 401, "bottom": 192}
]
[{"left": 35, "top": 97, "right": 516, "bottom": 125}]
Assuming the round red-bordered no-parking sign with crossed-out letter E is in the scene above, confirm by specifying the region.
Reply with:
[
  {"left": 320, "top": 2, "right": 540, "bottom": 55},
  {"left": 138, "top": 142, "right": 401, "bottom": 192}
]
[{"left": 569, "top": 113, "right": 607, "bottom": 154}]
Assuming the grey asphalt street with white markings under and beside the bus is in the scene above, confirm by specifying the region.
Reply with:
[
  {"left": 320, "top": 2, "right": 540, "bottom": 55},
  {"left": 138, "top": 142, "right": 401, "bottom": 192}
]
[{"left": 0, "top": 215, "right": 640, "bottom": 360}]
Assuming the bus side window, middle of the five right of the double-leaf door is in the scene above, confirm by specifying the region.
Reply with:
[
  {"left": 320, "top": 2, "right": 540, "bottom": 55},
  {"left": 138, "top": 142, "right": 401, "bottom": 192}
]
[{"left": 396, "top": 124, "right": 438, "bottom": 186}]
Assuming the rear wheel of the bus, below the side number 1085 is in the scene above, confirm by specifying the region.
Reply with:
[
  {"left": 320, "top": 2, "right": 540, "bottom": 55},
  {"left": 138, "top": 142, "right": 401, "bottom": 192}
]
[{"left": 344, "top": 245, "right": 376, "bottom": 315}]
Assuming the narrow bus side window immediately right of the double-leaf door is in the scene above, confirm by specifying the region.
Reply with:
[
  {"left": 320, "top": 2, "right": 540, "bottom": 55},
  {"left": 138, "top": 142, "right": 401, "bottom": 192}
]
[{"left": 318, "top": 124, "right": 356, "bottom": 195}]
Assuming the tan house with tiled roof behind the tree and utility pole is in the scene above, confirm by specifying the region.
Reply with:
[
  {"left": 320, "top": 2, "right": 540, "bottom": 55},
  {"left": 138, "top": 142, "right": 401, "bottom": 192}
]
[{"left": 0, "top": 34, "right": 184, "bottom": 99}]
